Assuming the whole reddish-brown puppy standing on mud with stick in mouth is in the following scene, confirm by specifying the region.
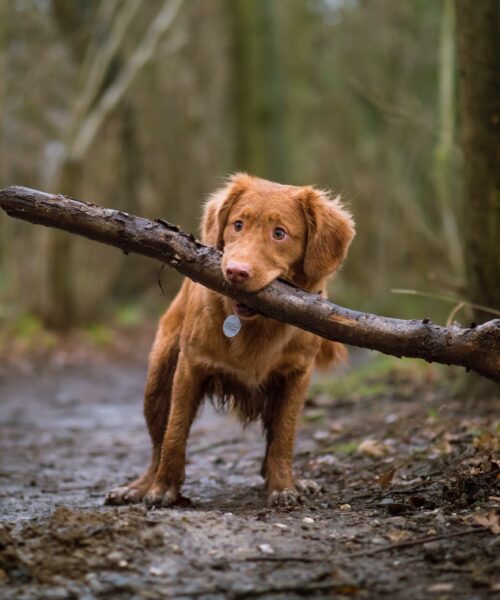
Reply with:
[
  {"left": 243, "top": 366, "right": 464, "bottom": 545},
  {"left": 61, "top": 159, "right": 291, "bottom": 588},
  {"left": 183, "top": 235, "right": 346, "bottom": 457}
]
[{"left": 107, "top": 174, "right": 354, "bottom": 506}]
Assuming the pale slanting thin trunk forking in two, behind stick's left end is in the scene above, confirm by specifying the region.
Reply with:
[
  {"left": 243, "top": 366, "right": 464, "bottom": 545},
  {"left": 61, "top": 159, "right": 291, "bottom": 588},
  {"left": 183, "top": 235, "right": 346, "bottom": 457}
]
[{"left": 45, "top": 0, "right": 184, "bottom": 329}]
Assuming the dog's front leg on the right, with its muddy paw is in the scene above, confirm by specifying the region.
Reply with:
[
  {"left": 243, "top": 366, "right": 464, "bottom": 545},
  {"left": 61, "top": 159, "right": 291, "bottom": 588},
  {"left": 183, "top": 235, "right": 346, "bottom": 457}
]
[{"left": 262, "top": 371, "right": 319, "bottom": 506}]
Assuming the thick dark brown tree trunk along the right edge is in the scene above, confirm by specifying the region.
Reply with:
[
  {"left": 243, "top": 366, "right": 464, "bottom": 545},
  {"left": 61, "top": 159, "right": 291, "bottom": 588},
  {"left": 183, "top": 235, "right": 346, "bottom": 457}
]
[{"left": 456, "top": 0, "right": 500, "bottom": 396}]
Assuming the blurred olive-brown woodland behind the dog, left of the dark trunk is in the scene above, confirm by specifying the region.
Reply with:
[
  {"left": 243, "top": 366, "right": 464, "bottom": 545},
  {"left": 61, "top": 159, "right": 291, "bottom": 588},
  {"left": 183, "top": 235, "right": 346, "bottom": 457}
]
[{"left": 0, "top": 0, "right": 466, "bottom": 334}]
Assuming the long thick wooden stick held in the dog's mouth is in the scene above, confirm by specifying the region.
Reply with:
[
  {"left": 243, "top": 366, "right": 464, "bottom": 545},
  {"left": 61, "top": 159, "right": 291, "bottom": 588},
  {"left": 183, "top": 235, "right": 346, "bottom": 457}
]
[{"left": 0, "top": 187, "right": 500, "bottom": 383}]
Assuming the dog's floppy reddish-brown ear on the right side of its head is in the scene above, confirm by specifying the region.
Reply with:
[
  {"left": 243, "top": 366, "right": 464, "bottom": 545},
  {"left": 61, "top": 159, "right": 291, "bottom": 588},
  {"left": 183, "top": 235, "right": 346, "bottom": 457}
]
[{"left": 300, "top": 187, "right": 355, "bottom": 281}]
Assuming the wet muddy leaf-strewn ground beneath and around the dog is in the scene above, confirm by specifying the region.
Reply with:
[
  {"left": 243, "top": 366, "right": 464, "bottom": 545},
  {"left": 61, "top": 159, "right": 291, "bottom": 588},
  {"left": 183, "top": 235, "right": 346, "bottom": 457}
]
[{"left": 0, "top": 350, "right": 500, "bottom": 600}]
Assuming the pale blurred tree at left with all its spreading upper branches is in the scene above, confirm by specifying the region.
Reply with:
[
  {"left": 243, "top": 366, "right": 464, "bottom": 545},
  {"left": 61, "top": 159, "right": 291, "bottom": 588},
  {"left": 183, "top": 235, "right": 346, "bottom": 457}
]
[{"left": 45, "top": 0, "right": 184, "bottom": 329}]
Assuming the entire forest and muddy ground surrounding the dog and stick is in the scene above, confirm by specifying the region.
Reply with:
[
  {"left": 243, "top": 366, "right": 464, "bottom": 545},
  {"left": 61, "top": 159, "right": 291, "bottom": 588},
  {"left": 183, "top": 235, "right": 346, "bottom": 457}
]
[{"left": 0, "top": 0, "right": 500, "bottom": 600}]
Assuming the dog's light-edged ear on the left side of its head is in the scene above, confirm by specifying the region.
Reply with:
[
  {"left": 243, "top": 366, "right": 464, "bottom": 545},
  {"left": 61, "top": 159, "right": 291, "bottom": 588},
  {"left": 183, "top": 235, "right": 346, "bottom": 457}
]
[{"left": 201, "top": 173, "right": 252, "bottom": 250}]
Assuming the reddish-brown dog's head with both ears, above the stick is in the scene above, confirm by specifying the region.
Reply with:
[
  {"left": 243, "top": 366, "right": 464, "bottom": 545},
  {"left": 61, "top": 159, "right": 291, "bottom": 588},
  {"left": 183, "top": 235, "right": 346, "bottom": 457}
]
[{"left": 202, "top": 174, "right": 354, "bottom": 316}]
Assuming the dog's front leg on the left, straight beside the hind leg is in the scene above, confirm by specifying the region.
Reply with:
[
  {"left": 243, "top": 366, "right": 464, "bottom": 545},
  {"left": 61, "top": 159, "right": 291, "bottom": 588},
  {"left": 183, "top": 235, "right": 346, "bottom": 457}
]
[{"left": 144, "top": 352, "right": 203, "bottom": 507}]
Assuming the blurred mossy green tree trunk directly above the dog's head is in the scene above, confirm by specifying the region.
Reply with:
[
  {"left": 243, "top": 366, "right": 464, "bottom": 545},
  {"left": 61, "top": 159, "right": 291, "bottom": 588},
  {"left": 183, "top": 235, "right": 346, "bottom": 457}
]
[{"left": 228, "top": 0, "right": 288, "bottom": 181}]
